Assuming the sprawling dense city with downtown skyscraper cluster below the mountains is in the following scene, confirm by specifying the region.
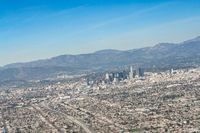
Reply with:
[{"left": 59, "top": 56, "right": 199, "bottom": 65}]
[{"left": 0, "top": 67, "right": 200, "bottom": 133}]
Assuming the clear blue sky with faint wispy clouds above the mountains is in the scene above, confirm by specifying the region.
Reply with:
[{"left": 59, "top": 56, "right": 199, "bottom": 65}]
[{"left": 0, "top": 0, "right": 200, "bottom": 66}]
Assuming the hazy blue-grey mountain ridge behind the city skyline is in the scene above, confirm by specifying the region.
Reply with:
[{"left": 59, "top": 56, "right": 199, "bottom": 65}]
[{"left": 0, "top": 36, "right": 200, "bottom": 80}]
